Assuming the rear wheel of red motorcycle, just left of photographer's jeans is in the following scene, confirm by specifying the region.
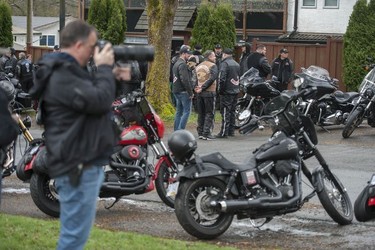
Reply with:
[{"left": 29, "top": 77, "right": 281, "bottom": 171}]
[{"left": 30, "top": 173, "right": 60, "bottom": 218}]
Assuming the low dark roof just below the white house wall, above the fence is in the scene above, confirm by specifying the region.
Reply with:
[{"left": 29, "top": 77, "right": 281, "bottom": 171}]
[{"left": 276, "top": 32, "right": 343, "bottom": 44}]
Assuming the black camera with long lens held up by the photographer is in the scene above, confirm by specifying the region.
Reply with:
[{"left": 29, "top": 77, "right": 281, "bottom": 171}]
[{"left": 97, "top": 40, "right": 155, "bottom": 62}]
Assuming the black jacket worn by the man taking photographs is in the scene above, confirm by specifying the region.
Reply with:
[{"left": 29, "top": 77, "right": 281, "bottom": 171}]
[{"left": 31, "top": 53, "right": 115, "bottom": 178}]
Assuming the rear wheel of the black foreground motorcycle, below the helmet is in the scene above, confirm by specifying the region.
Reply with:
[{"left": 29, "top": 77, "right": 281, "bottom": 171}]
[{"left": 175, "top": 178, "right": 233, "bottom": 239}]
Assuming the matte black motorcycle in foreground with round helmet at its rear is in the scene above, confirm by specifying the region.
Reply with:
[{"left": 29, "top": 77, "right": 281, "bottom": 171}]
[{"left": 168, "top": 88, "right": 353, "bottom": 239}]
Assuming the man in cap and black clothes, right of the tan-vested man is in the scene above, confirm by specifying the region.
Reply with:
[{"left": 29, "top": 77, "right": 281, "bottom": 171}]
[{"left": 216, "top": 48, "right": 240, "bottom": 138}]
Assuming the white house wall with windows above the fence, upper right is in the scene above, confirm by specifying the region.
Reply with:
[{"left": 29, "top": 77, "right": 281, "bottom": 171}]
[{"left": 287, "top": 0, "right": 357, "bottom": 40}]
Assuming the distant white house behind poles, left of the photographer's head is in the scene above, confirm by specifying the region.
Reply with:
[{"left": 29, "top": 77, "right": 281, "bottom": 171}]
[{"left": 12, "top": 16, "right": 76, "bottom": 49}]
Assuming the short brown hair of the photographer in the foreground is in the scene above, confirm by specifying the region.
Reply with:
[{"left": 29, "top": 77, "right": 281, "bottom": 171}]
[{"left": 60, "top": 20, "right": 97, "bottom": 48}]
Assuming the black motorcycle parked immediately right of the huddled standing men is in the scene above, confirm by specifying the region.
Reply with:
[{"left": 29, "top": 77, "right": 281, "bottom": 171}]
[{"left": 235, "top": 68, "right": 280, "bottom": 128}]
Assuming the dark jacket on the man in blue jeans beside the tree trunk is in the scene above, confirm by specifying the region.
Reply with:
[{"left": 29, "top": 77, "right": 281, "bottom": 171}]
[{"left": 172, "top": 58, "right": 193, "bottom": 96}]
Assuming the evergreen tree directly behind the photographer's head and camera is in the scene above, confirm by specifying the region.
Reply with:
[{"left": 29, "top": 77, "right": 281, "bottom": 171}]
[{"left": 88, "top": 0, "right": 126, "bottom": 44}]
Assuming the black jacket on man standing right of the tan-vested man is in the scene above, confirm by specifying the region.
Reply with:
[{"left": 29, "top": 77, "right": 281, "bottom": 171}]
[{"left": 218, "top": 56, "right": 240, "bottom": 95}]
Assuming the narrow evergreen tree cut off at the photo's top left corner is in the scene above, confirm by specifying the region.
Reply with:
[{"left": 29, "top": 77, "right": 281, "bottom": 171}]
[{"left": 0, "top": 0, "right": 13, "bottom": 47}]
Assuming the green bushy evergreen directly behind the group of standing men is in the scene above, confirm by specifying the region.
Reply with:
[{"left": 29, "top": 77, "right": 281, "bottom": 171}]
[{"left": 190, "top": 2, "right": 236, "bottom": 50}]
